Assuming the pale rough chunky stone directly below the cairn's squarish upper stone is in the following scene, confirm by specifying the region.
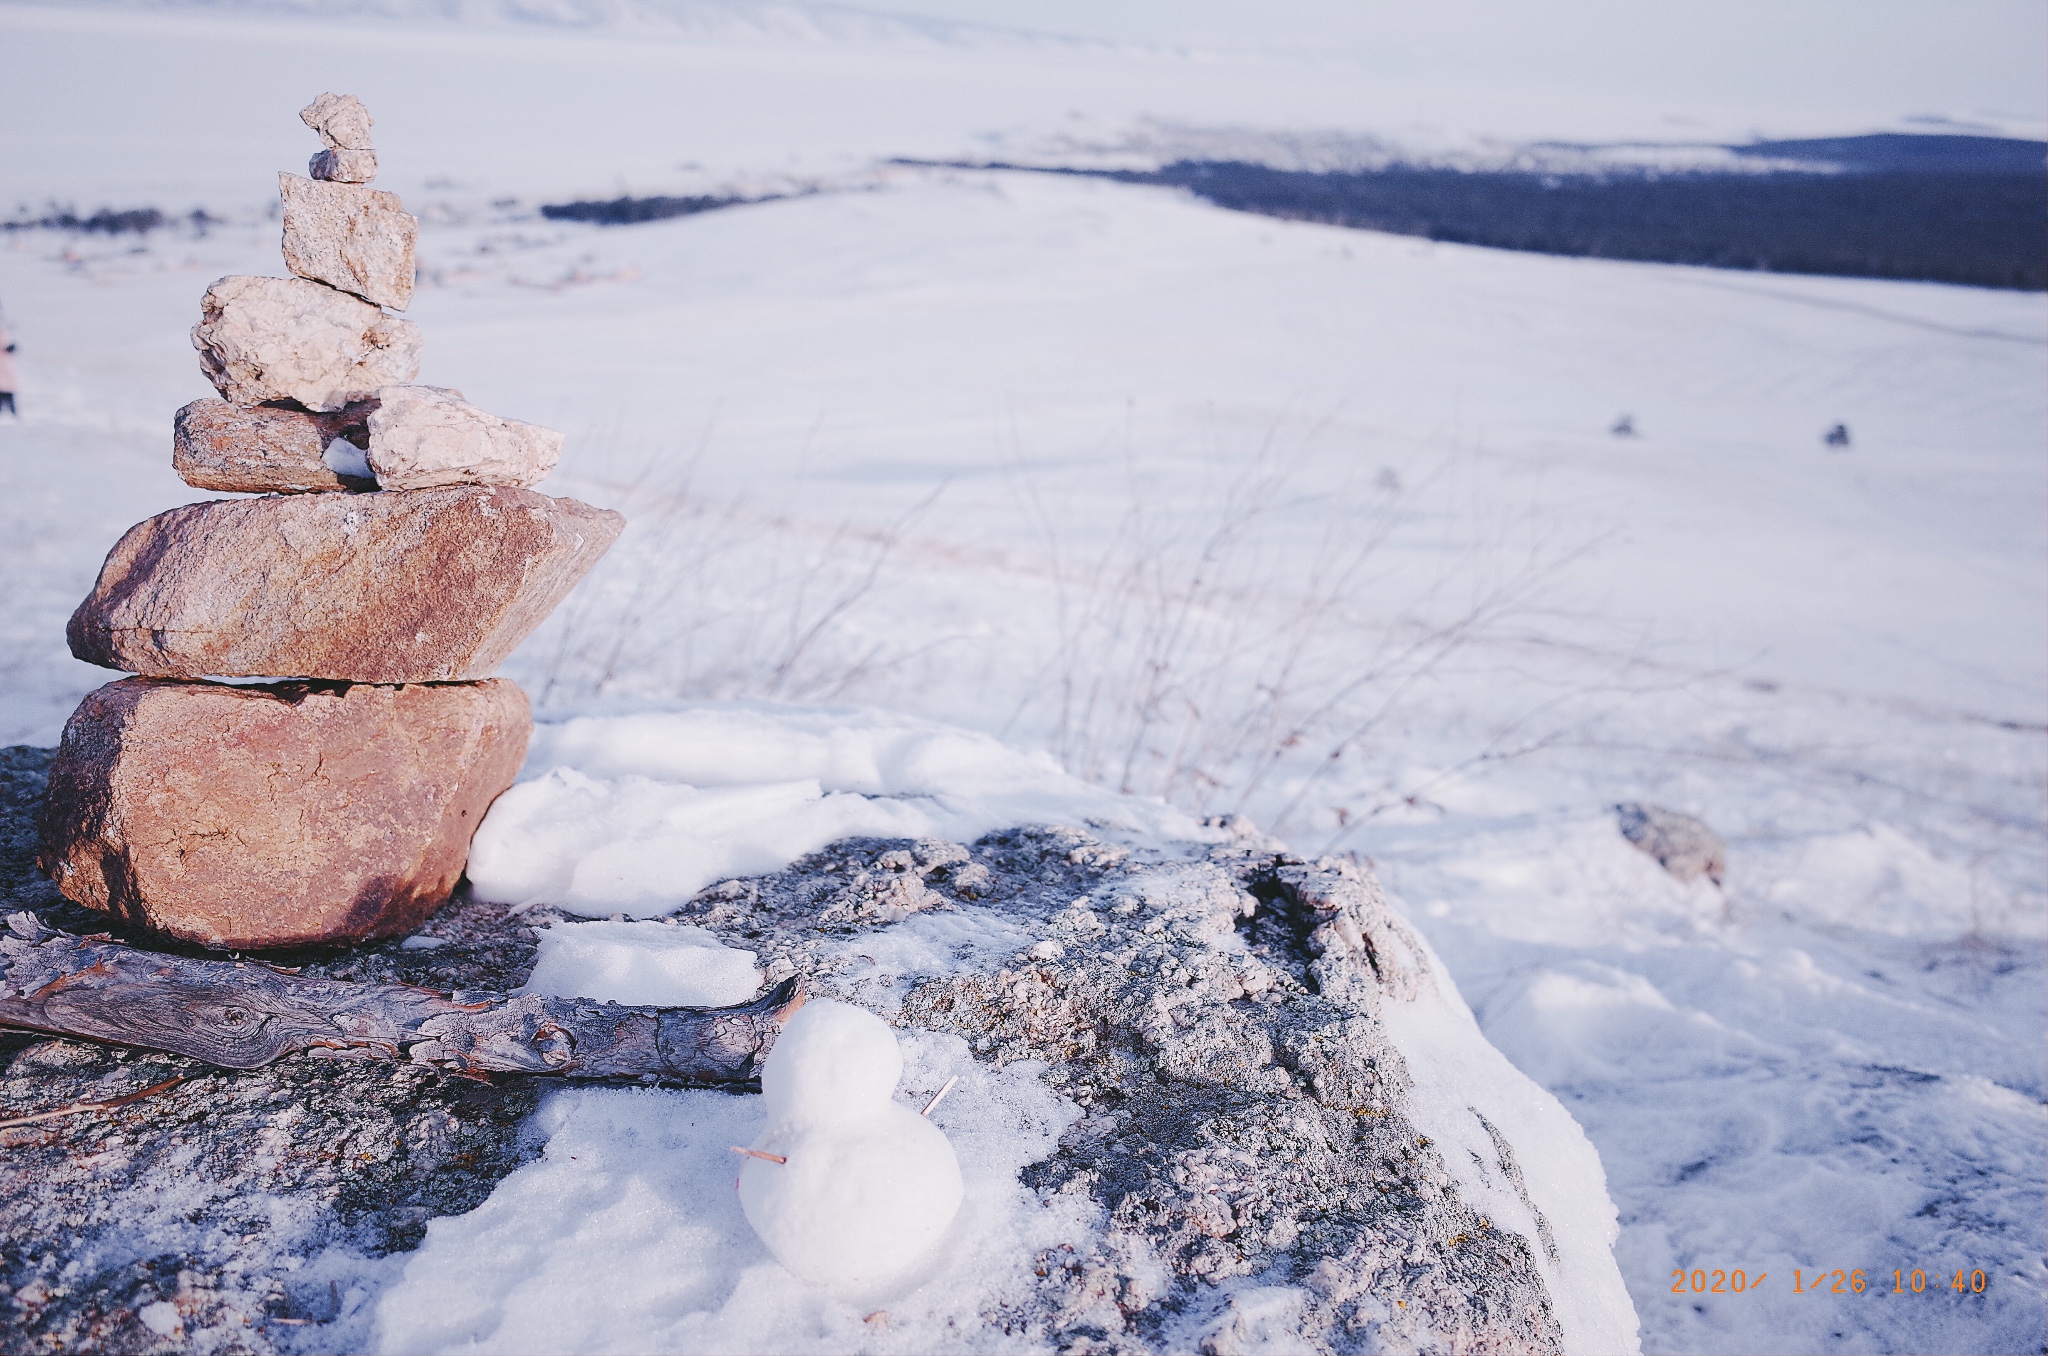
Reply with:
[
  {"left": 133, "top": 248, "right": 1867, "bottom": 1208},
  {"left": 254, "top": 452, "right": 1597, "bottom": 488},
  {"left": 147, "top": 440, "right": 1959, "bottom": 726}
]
[{"left": 193, "top": 277, "right": 420, "bottom": 410}]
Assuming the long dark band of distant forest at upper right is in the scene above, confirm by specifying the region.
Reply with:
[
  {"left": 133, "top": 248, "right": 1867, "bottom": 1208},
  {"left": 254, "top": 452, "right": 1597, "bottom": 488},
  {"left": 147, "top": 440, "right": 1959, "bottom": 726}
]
[{"left": 917, "top": 135, "right": 2048, "bottom": 291}]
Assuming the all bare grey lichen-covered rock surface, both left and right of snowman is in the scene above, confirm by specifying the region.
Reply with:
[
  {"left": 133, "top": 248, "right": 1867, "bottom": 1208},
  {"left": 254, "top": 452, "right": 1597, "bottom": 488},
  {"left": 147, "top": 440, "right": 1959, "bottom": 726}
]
[{"left": 0, "top": 750, "right": 1632, "bottom": 1356}]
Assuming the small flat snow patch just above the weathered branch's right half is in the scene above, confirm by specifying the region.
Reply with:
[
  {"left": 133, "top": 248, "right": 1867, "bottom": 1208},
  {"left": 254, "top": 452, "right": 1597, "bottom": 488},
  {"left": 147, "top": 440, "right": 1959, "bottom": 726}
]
[{"left": 520, "top": 922, "right": 762, "bottom": 1008}]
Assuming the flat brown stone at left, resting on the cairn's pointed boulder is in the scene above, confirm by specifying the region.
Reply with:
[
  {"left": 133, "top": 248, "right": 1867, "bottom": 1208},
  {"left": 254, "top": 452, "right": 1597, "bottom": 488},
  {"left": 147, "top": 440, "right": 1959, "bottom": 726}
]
[{"left": 170, "top": 399, "right": 377, "bottom": 494}]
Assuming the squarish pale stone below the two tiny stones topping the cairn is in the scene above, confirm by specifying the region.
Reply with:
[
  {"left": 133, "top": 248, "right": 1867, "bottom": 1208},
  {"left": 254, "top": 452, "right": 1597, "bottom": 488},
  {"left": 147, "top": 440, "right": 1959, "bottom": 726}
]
[{"left": 276, "top": 174, "right": 420, "bottom": 311}]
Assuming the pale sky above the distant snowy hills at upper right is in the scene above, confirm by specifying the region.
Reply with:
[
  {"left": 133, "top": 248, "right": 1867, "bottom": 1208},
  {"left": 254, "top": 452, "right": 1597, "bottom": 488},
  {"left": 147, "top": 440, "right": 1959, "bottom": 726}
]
[{"left": 860, "top": 0, "right": 2048, "bottom": 131}]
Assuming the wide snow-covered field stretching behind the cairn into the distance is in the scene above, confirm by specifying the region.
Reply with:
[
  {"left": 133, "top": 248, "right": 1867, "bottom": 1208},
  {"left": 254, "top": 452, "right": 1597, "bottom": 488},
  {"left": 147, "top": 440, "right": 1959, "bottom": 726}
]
[{"left": 0, "top": 4, "right": 2048, "bottom": 1352}]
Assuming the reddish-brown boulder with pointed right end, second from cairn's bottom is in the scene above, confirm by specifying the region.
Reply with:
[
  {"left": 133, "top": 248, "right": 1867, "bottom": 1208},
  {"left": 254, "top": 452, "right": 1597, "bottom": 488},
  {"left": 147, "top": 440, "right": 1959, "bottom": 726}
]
[{"left": 68, "top": 485, "right": 625, "bottom": 682}]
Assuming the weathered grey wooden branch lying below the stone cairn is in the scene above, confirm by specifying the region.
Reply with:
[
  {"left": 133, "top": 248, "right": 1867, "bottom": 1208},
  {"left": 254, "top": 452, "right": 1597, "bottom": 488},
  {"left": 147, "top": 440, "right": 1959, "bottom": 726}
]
[{"left": 0, "top": 914, "right": 803, "bottom": 1084}]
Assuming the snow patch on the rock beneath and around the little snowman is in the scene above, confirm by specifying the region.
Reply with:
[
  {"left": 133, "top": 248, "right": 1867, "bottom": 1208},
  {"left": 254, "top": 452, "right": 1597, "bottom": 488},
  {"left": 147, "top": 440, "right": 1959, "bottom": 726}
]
[{"left": 367, "top": 1034, "right": 1092, "bottom": 1356}]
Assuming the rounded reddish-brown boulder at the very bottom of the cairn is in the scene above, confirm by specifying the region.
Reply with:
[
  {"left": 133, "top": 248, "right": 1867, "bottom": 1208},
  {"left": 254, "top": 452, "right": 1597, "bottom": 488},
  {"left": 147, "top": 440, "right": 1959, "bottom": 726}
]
[{"left": 39, "top": 678, "right": 532, "bottom": 948}]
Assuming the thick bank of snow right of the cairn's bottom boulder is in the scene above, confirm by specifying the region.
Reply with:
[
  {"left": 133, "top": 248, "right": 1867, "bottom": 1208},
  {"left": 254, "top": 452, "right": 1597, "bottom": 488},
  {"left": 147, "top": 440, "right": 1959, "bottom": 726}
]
[{"left": 469, "top": 703, "right": 1214, "bottom": 918}]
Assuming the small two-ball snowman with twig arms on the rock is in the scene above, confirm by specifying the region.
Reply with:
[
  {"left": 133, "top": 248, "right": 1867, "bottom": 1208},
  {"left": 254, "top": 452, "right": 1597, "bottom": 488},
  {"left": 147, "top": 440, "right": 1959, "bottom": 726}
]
[{"left": 739, "top": 1000, "right": 961, "bottom": 1293}]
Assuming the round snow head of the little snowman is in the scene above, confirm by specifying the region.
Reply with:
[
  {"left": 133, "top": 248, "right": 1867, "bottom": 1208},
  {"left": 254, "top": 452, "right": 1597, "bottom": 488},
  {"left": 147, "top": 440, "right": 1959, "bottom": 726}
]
[{"left": 762, "top": 998, "right": 903, "bottom": 1125}]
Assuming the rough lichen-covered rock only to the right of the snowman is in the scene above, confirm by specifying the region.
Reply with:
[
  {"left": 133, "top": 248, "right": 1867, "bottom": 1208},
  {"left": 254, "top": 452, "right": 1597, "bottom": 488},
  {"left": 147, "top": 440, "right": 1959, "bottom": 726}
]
[{"left": 680, "top": 830, "right": 1563, "bottom": 1352}]
